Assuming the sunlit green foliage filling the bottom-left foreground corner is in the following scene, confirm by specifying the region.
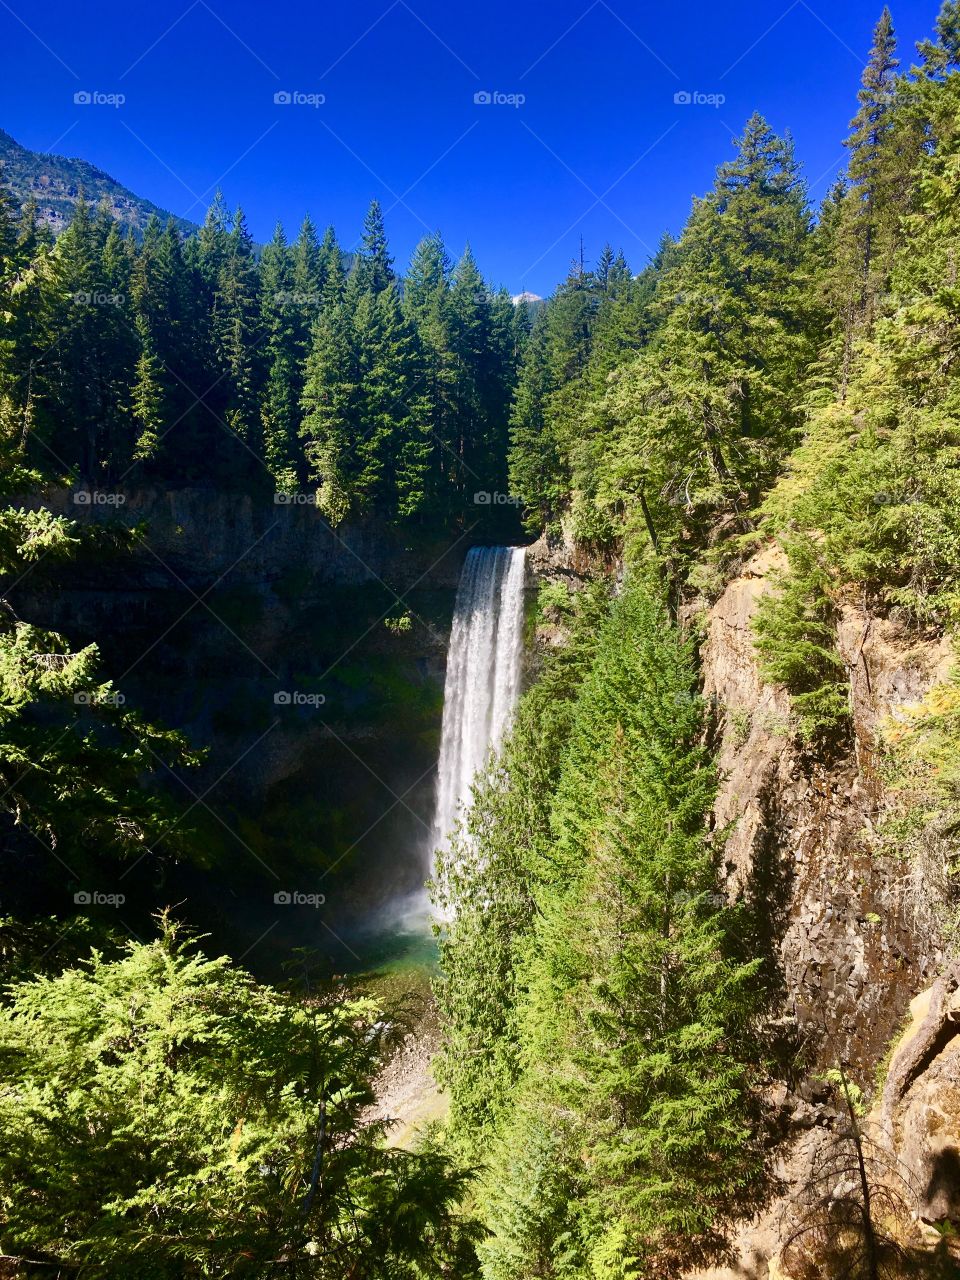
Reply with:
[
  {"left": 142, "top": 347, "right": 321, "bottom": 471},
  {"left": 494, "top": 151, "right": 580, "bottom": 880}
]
[{"left": 0, "top": 922, "right": 474, "bottom": 1280}]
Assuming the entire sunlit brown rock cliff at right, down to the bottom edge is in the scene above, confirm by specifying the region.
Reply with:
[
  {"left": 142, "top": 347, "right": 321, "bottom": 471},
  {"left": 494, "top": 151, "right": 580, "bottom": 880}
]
[{"left": 696, "top": 550, "right": 960, "bottom": 1280}]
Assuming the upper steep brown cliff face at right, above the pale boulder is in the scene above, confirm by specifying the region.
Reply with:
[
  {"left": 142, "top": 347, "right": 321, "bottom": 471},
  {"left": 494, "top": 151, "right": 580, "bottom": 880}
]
[{"left": 701, "top": 552, "right": 951, "bottom": 1076}]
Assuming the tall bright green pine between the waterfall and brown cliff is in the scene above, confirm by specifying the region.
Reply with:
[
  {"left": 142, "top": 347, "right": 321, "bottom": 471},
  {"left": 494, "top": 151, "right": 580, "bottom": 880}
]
[{"left": 493, "top": 579, "right": 759, "bottom": 1275}]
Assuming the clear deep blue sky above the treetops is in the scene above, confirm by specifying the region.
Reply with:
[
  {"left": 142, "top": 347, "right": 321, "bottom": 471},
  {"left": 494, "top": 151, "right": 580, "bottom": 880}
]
[{"left": 0, "top": 0, "right": 938, "bottom": 294}]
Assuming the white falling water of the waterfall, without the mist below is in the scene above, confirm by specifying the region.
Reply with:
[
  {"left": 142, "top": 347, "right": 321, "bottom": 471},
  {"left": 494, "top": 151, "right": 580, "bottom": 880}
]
[{"left": 431, "top": 547, "right": 525, "bottom": 880}]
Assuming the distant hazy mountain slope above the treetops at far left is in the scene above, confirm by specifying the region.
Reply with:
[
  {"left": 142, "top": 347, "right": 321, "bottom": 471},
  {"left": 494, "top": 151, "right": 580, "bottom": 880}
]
[{"left": 0, "top": 129, "right": 197, "bottom": 236}]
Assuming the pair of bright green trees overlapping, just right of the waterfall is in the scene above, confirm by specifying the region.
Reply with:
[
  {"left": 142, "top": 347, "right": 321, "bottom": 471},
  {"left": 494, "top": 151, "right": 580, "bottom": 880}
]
[{"left": 439, "top": 583, "right": 760, "bottom": 1280}]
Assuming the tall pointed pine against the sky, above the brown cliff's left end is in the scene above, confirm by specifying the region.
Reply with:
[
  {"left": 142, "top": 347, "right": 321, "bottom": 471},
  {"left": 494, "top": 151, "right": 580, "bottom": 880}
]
[{"left": 600, "top": 116, "right": 822, "bottom": 552}]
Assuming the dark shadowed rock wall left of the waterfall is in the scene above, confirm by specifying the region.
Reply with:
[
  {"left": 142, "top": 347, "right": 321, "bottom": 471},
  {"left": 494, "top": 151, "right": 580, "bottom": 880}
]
[{"left": 10, "top": 489, "right": 467, "bottom": 964}]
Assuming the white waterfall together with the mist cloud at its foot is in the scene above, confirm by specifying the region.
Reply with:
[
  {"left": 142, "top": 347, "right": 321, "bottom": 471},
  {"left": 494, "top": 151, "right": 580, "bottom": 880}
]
[{"left": 358, "top": 547, "right": 526, "bottom": 963}]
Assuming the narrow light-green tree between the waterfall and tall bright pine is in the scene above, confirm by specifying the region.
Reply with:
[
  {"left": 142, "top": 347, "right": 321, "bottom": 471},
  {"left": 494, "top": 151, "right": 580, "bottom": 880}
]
[{"left": 434, "top": 586, "right": 605, "bottom": 1162}]
